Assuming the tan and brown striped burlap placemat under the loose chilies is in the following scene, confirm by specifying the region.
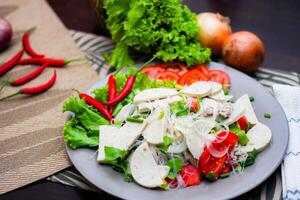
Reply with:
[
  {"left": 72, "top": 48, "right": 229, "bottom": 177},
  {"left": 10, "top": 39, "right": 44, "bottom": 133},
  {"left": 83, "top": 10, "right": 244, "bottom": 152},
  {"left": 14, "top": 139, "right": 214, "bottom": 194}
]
[{"left": 0, "top": 0, "right": 97, "bottom": 194}]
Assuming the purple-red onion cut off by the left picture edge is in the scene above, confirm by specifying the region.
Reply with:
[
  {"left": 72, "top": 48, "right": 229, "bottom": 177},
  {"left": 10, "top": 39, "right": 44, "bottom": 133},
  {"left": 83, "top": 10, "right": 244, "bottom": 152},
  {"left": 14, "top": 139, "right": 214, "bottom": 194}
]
[{"left": 0, "top": 17, "right": 12, "bottom": 51}]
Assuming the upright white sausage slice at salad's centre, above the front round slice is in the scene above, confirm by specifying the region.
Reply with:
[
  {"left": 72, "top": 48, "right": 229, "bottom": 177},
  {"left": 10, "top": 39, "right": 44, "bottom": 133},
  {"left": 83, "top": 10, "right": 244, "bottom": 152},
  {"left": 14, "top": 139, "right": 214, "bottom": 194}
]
[{"left": 143, "top": 105, "right": 168, "bottom": 144}]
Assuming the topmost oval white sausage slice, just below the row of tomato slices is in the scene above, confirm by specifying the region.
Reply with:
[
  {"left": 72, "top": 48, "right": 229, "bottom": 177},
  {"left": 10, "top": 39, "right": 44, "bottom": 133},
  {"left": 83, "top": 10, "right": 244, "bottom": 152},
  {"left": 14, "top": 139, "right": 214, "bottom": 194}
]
[{"left": 181, "top": 81, "right": 211, "bottom": 97}]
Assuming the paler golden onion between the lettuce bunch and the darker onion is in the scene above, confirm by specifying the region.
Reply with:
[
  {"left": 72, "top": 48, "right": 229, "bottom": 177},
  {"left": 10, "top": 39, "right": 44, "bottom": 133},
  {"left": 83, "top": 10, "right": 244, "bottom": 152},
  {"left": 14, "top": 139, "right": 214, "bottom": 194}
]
[{"left": 197, "top": 12, "right": 232, "bottom": 56}]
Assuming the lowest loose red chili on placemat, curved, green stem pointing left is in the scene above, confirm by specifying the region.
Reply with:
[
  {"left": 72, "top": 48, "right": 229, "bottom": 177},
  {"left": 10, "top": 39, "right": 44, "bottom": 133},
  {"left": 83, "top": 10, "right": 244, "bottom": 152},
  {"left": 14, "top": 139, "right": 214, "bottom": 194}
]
[{"left": 0, "top": 70, "right": 56, "bottom": 101}]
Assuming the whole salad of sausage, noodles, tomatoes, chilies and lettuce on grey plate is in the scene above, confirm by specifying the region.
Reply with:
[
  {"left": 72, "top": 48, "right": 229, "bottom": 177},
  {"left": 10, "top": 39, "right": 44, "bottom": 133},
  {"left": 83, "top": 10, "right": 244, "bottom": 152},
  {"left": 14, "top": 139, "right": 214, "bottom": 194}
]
[{"left": 63, "top": 63, "right": 272, "bottom": 189}]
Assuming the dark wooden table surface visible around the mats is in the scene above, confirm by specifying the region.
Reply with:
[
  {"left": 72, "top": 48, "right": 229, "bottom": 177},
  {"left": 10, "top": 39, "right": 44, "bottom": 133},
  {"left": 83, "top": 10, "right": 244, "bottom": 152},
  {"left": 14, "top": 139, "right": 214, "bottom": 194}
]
[{"left": 0, "top": 0, "right": 300, "bottom": 200}]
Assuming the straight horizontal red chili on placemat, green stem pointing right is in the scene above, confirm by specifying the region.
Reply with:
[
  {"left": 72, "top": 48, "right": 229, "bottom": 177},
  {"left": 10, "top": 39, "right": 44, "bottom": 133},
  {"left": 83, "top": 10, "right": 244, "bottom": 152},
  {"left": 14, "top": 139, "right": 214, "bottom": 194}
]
[{"left": 18, "top": 57, "right": 82, "bottom": 67}]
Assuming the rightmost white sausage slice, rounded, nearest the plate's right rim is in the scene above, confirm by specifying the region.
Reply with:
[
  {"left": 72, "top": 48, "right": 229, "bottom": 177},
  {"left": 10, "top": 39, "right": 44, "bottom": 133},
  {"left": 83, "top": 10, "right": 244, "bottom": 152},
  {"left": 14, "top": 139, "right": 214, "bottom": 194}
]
[{"left": 241, "top": 123, "right": 272, "bottom": 152}]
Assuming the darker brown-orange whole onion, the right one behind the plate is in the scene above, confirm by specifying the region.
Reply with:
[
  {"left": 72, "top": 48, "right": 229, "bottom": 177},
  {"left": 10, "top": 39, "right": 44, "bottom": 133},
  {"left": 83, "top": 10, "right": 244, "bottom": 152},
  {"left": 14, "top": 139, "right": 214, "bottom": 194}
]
[{"left": 222, "top": 31, "right": 265, "bottom": 73}]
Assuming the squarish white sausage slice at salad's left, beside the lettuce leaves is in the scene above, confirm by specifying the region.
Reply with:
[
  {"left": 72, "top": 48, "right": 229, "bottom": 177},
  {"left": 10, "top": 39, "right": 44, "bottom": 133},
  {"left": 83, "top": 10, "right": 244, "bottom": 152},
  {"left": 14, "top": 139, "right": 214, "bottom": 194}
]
[{"left": 97, "top": 122, "right": 146, "bottom": 162}]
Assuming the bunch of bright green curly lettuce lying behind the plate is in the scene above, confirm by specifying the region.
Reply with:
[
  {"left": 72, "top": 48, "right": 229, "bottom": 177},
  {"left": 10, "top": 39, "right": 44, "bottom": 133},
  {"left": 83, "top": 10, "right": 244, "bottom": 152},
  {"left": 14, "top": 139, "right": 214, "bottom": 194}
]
[{"left": 103, "top": 0, "right": 211, "bottom": 69}]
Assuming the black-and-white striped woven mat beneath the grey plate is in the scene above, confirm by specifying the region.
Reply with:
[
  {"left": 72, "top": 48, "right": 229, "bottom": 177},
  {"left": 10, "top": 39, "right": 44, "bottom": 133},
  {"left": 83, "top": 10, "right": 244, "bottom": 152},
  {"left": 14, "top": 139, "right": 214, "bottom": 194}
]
[{"left": 48, "top": 31, "right": 300, "bottom": 200}]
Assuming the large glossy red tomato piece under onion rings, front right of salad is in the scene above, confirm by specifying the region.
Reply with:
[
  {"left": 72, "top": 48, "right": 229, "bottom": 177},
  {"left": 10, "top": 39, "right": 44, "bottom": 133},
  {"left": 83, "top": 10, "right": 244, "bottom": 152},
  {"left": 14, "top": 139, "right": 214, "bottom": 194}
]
[{"left": 199, "top": 131, "right": 239, "bottom": 180}]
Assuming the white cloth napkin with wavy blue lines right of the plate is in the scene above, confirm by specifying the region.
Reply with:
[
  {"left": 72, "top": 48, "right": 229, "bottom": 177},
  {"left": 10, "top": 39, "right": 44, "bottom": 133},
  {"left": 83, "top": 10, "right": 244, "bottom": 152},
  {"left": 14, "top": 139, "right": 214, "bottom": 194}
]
[{"left": 273, "top": 84, "right": 300, "bottom": 200}]
